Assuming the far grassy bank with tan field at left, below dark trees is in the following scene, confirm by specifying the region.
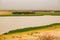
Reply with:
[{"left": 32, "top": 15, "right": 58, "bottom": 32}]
[{"left": 0, "top": 12, "right": 60, "bottom": 16}]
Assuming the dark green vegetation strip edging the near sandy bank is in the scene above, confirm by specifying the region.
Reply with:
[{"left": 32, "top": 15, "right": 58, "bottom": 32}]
[{"left": 4, "top": 23, "right": 60, "bottom": 34}]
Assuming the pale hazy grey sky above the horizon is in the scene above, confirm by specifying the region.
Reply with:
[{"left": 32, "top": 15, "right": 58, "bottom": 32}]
[{"left": 0, "top": 0, "right": 60, "bottom": 10}]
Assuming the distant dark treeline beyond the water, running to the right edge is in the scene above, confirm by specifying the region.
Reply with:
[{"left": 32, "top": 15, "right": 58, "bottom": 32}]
[{"left": 12, "top": 10, "right": 60, "bottom": 14}]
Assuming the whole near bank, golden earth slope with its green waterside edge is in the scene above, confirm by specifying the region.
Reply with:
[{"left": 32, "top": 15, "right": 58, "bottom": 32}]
[{"left": 0, "top": 23, "right": 60, "bottom": 40}]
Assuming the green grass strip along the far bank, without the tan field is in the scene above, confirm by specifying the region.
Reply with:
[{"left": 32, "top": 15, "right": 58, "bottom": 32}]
[{"left": 0, "top": 12, "right": 60, "bottom": 16}]
